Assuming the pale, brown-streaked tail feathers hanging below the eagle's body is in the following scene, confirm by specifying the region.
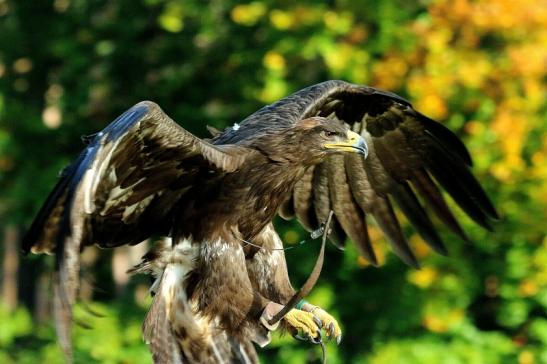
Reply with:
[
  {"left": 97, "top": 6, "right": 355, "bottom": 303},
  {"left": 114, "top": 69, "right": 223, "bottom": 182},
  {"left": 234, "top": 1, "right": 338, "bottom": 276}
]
[{"left": 134, "top": 239, "right": 258, "bottom": 364}]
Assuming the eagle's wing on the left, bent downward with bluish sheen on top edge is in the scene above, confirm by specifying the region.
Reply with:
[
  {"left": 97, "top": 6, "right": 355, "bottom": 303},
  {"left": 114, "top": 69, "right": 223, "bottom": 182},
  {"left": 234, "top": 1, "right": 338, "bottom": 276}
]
[{"left": 23, "top": 101, "right": 250, "bottom": 358}]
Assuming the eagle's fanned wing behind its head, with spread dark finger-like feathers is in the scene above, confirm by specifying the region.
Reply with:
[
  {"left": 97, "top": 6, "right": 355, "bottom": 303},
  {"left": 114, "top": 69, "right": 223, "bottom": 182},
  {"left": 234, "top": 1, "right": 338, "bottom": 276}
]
[{"left": 214, "top": 81, "right": 498, "bottom": 266}]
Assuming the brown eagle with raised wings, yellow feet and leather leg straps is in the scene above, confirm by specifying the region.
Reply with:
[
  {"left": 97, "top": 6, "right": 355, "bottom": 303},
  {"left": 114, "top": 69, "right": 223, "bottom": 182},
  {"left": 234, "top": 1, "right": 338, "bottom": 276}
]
[{"left": 22, "top": 80, "right": 498, "bottom": 363}]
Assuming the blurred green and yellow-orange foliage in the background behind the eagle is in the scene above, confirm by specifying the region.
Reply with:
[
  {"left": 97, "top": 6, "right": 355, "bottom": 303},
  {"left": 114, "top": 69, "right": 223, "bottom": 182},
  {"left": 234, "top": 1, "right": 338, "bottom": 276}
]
[{"left": 0, "top": 0, "right": 547, "bottom": 364}]
